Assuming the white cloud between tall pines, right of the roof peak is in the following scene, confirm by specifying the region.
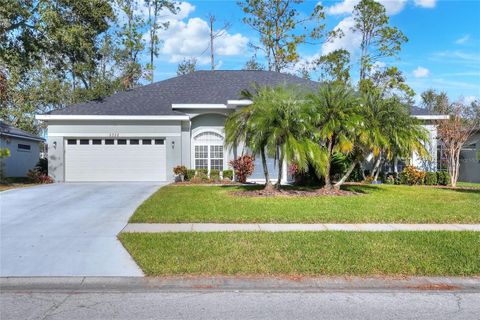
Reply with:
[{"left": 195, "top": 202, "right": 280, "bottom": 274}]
[{"left": 322, "top": 16, "right": 362, "bottom": 54}]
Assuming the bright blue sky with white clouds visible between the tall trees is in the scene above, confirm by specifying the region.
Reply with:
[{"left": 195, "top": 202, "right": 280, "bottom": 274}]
[{"left": 143, "top": 0, "right": 480, "bottom": 101}]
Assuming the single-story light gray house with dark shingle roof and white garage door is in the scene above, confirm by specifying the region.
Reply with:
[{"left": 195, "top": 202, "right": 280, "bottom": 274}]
[{"left": 37, "top": 70, "right": 442, "bottom": 181}]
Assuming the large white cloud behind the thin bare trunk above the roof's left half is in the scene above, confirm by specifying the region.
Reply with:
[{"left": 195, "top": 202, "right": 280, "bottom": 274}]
[{"left": 142, "top": 2, "right": 248, "bottom": 64}]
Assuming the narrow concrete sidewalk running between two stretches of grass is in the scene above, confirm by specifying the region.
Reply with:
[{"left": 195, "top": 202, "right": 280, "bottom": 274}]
[{"left": 122, "top": 223, "right": 480, "bottom": 233}]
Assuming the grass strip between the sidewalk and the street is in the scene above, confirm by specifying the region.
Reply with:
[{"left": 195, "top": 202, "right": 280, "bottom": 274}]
[{"left": 119, "top": 232, "right": 480, "bottom": 276}]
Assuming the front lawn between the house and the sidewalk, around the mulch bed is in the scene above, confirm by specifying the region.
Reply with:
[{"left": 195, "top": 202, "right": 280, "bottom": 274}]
[{"left": 130, "top": 185, "right": 480, "bottom": 223}]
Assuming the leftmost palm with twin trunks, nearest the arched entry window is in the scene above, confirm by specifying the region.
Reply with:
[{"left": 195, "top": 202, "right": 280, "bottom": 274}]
[{"left": 225, "top": 86, "right": 322, "bottom": 189}]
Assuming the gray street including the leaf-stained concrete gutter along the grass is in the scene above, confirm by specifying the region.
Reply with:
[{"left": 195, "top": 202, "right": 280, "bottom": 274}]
[{"left": 0, "top": 277, "right": 480, "bottom": 320}]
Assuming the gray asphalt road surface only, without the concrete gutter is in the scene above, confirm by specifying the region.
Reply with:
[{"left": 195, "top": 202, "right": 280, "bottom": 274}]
[{"left": 0, "top": 291, "right": 480, "bottom": 320}]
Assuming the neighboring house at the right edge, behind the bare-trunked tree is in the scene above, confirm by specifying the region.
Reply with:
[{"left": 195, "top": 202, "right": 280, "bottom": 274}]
[{"left": 458, "top": 129, "right": 480, "bottom": 182}]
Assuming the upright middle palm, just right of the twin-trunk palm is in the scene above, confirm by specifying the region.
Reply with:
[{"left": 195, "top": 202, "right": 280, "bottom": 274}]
[{"left": 307, "top": 83, "right": 362, "bottom": 189}]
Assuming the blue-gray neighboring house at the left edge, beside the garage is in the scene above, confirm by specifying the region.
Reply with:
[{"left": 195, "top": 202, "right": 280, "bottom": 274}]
[{"left": 0, "top": 121, "right": 45, "bottom": 177}]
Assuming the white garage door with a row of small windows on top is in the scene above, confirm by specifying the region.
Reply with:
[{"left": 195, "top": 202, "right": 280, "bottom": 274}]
[{"left": 65, "top": 138, "right": 167, "bottom": 181}]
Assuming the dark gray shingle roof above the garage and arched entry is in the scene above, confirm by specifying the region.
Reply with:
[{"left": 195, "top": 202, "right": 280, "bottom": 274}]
[{"left": 50, "top": 70, "right": 319, "bottom": 115}]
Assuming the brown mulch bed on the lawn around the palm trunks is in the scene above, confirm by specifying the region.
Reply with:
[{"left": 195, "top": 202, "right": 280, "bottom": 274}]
[{"left": 231, "top": 188, "right": 362, "bottom": 197}]
